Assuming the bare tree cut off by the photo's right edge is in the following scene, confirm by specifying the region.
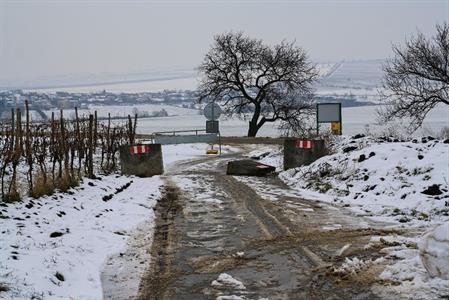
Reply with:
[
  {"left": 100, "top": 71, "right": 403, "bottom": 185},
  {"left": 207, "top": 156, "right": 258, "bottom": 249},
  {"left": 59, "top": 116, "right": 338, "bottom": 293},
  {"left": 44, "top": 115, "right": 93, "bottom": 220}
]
[{"left": 378, "top": 23, "right": 449, "bottom": 131}]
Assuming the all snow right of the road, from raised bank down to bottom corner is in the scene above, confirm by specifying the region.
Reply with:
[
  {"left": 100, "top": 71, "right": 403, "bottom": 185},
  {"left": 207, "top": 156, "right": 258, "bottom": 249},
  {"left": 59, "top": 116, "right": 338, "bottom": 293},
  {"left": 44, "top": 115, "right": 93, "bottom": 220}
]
[{"left": 280, "top": 136, "right": 449, "bottom": 299}]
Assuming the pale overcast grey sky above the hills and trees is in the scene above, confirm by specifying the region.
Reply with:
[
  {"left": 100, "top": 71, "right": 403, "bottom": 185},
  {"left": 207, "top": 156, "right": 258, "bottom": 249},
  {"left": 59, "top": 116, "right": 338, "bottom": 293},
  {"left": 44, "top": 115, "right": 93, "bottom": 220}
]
[{"left": 0, "top": 0, "right": 449, "bottom": 81}]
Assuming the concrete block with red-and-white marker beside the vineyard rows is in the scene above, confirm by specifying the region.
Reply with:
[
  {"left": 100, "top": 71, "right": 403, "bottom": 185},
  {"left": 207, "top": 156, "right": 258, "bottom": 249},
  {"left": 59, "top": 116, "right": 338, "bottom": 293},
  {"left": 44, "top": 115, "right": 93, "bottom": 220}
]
[{"left": 120, "top": 144, "right": 164, "bottom": 177}]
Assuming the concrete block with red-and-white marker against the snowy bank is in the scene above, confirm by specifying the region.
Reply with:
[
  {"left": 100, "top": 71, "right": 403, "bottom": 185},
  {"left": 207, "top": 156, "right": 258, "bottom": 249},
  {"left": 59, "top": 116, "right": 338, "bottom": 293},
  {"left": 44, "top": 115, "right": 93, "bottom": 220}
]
[{"left": 284, "top": 138, "right": 326, "bottom": 170}]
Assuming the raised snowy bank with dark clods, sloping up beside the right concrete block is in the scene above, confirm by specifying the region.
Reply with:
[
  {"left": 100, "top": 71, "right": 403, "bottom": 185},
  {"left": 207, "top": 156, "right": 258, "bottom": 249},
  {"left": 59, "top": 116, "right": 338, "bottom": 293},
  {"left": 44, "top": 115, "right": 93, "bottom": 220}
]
[{"left": 280, "top": 137, "right": 449, "bottom": 223}]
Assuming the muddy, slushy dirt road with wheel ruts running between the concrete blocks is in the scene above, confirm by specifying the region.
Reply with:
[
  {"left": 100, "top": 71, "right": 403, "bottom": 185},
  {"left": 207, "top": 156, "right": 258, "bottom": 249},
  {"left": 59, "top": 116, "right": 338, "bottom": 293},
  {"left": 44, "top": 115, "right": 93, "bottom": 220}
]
[{"left": 139, "top": 155, "right": 402, "bottom": 299}]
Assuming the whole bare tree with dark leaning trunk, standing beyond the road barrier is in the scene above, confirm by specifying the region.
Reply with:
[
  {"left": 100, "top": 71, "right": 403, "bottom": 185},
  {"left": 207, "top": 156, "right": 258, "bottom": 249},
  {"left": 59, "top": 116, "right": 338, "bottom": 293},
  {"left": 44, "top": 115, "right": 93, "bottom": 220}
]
[{"left": 199, "top": 32, "right": 317, "bottom": 137}]
